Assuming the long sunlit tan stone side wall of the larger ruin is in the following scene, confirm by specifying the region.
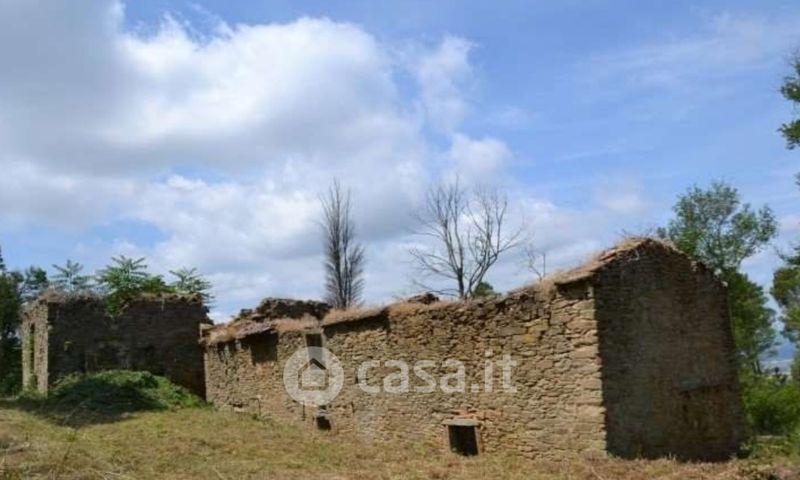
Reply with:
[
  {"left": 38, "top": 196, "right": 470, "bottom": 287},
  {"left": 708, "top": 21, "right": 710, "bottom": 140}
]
[{"left": 205, "top": 287, "right": 605, "bottom": 456}]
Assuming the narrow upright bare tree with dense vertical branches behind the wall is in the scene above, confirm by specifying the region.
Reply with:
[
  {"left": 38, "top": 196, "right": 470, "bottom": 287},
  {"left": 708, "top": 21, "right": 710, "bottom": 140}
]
[{"left": 320, "top": 180, "right": 364, "bottom": 309}]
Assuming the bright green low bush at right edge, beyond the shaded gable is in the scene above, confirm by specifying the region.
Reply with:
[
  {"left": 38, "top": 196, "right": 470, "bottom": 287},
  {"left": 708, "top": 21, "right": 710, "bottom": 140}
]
[{"left": 742, "top": 375, "right": 800, "bottom": 435}]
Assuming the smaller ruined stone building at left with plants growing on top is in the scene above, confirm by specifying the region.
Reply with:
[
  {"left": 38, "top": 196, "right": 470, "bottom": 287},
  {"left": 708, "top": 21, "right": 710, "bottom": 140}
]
[{"left": 21, "top": 292, "right": 209, "bottom": 396}]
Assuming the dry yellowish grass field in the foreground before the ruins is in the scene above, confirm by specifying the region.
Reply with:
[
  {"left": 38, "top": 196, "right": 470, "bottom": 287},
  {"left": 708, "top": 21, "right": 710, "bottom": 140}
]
[{"left": 0, "top": 404, "right": 797, "bottom": 480}]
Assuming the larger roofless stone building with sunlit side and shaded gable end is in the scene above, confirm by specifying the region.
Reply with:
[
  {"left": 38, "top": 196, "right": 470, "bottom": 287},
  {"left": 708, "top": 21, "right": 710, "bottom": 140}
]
[{"left": 201, "top": 239, "right": 743, "bottom": 460}]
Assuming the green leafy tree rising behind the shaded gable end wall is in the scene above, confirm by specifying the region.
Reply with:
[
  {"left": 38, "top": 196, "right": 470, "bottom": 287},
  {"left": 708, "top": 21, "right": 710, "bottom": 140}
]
[{"left": 658, "top": 182, "right": 777, "bottom": 374}]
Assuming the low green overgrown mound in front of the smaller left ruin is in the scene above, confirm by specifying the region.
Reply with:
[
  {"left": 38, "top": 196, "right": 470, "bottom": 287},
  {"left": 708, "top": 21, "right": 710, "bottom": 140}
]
[{"left": 45, "top": 370, "right": 204, "bottom": 415}]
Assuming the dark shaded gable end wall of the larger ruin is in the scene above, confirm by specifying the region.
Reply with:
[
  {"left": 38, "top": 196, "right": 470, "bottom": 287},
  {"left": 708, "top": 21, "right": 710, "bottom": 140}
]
[{"left": 591, "top": 242, "right": 743, "bottom": 460}]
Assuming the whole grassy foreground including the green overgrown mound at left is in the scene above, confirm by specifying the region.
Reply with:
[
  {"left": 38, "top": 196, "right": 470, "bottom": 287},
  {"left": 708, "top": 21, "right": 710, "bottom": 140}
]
[{"left": 0, "top": 372, "right": 800, "bottom": 480}]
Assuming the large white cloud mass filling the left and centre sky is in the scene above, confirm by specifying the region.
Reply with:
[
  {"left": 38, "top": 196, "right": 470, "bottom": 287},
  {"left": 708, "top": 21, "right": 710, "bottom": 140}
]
[{"left": 0, "top": 0, "right": 648, "bottom": 316}]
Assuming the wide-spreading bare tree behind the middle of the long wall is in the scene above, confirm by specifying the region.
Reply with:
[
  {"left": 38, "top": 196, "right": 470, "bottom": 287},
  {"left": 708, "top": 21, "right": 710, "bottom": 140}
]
[{"left": 410, "top": 180, "right": 522, "bottom": 298}]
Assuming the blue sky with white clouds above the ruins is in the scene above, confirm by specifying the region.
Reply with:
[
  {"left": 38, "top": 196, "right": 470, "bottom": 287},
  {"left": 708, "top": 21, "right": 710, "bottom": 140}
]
[{"left": 0, "top": 0, "right": 800, "bottom": 348}]
